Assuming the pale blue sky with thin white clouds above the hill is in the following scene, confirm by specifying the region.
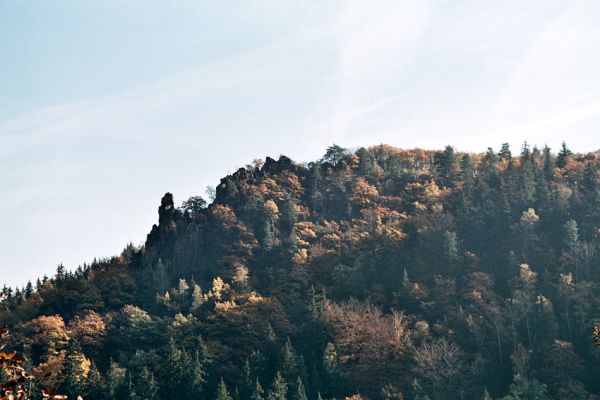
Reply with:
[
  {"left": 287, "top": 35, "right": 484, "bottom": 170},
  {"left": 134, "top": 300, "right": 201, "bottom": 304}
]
[{"left": 0, "top": 0, "right": 600, "bottom": 286}]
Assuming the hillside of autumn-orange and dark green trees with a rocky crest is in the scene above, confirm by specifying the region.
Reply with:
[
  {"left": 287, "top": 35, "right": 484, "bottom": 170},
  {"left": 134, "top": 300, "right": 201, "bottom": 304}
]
[{"left": 0, "top": 144, "right": 600, "bottom": 400}]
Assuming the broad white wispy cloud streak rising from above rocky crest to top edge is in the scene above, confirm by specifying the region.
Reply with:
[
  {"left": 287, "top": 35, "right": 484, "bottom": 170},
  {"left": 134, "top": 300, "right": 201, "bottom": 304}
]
[{"left": 312, "top": 1, "right": 435, "bottom": 141}]
